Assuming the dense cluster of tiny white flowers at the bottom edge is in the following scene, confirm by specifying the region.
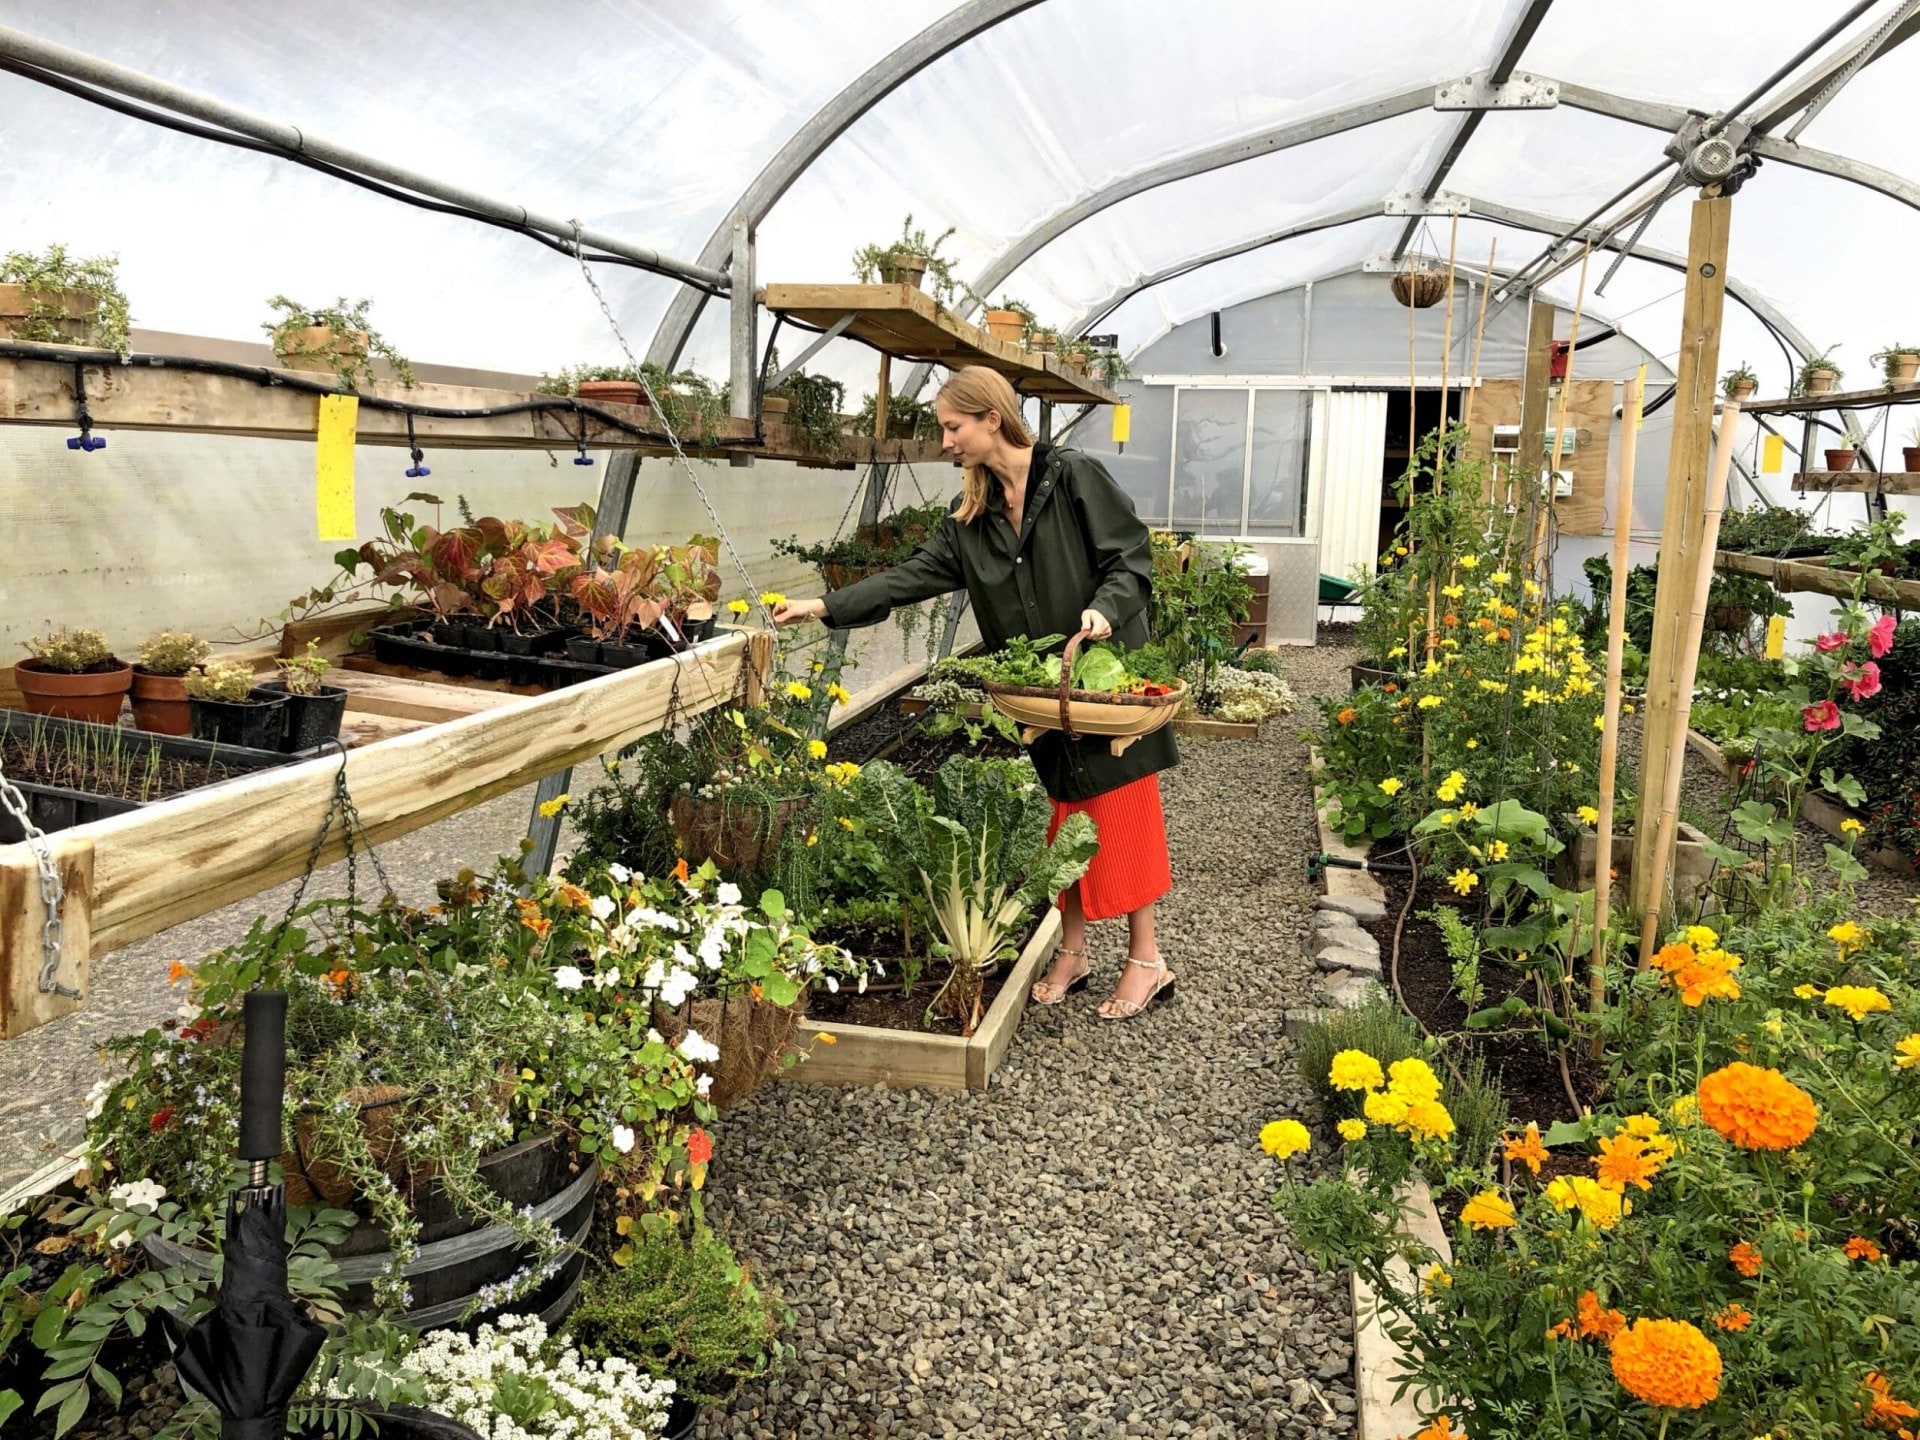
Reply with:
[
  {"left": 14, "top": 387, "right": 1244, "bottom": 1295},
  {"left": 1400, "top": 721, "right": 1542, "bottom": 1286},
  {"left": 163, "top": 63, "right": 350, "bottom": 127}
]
[{"left": 403, "top": 1315, "right": 674, "bottom": 1440}]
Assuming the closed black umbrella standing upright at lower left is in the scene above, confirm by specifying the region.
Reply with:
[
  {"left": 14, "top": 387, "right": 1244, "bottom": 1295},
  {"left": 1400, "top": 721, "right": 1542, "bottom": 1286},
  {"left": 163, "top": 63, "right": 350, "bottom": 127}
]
[{"left": 173, "top": 991, "right": 326, "bottom": 1440}]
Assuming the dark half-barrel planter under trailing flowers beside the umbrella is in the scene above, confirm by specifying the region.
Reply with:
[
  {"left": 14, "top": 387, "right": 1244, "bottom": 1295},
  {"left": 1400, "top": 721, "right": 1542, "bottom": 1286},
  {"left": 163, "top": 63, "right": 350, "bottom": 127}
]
[{"left": 140, "top": 1135, "right": 599, "bottom": 1329}]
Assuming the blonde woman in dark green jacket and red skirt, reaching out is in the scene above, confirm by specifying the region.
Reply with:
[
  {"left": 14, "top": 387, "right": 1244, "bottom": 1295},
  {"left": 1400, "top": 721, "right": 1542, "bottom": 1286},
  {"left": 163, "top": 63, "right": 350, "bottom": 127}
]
[{"left": 774, "top": 367, "right": 1179, "bottom": 1020}]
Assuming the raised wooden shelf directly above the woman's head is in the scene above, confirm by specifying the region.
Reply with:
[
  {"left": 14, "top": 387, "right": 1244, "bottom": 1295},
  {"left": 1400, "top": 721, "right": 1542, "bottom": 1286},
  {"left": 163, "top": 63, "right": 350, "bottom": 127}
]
[{"left": 762, "top": 284, "right": 1119, "bottom": 405}]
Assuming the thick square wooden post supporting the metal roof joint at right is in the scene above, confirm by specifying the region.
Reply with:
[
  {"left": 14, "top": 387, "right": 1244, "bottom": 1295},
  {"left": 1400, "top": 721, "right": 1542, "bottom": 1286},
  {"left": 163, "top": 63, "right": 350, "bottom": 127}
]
[{"left": 1632, "top": 196, "right": 1734, "bottom": 914}]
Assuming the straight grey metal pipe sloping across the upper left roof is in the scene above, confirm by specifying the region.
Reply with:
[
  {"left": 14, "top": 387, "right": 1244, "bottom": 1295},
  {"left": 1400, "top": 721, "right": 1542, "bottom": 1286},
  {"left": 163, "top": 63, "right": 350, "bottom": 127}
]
[{"left": 0, "top": 25, "right": 730, "bottom": 290}]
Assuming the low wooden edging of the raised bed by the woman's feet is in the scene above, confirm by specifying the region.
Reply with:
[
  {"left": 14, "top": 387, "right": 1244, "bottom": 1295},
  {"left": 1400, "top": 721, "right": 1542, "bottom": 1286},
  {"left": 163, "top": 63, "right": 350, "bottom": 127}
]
[{"left": 781, "top": 906, "right": 1060, "bottom": 1091}]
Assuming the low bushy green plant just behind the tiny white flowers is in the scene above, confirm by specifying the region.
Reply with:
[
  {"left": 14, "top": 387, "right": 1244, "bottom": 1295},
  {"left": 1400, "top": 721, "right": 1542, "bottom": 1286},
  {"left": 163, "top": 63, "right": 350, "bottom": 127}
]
[{"left": 566, "top": 1225, "right": 791, "bottom": 1405}]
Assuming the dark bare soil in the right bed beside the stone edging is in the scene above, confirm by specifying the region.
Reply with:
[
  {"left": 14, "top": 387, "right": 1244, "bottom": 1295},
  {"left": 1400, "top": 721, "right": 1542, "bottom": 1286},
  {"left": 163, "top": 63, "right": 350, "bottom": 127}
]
[{"left": 1363, "top": 876, "right": 1607, "bottom": 1129}]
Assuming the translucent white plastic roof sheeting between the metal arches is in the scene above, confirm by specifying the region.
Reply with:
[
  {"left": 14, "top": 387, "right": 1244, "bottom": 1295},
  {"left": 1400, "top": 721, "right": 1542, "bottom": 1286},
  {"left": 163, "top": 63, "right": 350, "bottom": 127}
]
[{"left": 0, "top": 0, "right": 1920, "bottom": 390}]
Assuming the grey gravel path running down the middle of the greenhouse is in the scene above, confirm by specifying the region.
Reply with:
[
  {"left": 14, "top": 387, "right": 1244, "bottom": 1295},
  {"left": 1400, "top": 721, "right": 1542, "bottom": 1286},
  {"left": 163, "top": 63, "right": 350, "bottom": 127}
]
[{"left": 701, "top": 651, "right": 1354, "bottom": 1440}]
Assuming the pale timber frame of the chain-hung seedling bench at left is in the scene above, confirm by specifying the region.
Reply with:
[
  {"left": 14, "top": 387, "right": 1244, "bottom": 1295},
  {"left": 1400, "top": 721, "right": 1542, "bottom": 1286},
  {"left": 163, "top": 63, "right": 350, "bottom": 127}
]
[{"left": 0, "top": 632, "right": 772, "bottom": 1039}]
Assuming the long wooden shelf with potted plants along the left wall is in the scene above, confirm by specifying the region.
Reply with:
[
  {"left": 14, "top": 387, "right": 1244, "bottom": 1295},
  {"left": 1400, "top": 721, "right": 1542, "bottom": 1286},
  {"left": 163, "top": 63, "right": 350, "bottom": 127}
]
[{"left": 0, "top": 346, "right": 945, "bottom": 467}]
